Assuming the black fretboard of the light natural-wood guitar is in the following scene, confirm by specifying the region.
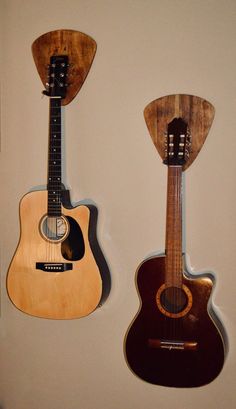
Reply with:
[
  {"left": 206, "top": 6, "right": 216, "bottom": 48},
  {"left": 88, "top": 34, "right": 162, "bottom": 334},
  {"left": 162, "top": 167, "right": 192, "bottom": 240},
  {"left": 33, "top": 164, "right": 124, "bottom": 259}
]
[{"left": 47, "top": 97, "right": 61, "bottom": 216}]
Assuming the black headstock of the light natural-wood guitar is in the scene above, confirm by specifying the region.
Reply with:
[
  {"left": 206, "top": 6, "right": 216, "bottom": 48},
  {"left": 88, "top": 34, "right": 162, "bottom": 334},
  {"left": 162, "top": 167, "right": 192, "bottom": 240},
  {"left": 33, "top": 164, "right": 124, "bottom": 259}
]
[{"left": 43, "top": 55, "right": 69, "bottom": 99}]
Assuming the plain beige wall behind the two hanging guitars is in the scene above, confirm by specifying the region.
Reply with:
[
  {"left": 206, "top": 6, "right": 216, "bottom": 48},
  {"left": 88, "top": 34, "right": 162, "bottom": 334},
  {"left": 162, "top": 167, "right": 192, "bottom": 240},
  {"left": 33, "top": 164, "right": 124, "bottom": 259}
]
[{"left": 0, "top": 0, "right": 236, "bottom": 409}]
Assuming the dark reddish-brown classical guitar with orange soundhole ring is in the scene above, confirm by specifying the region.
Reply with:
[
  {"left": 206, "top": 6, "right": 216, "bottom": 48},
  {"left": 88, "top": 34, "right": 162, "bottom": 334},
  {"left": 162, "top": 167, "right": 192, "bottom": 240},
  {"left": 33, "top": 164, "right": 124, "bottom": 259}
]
[{"left": 125, "top": 95, "right": 226, "bottom": 387}]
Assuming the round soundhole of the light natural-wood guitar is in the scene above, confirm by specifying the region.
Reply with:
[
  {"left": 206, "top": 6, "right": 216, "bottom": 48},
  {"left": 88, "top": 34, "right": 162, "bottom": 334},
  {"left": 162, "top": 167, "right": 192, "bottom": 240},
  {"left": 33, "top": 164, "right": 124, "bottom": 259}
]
[{"left": 40, "top": 215, "right": 70, "bottom": 243}]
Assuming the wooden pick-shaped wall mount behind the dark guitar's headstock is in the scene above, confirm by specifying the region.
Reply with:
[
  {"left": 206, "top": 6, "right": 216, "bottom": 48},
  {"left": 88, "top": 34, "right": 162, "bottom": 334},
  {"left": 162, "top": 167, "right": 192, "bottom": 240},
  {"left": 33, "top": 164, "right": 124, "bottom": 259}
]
[{"left": 144, "top": 94, "right": 215, "bottom": 170}]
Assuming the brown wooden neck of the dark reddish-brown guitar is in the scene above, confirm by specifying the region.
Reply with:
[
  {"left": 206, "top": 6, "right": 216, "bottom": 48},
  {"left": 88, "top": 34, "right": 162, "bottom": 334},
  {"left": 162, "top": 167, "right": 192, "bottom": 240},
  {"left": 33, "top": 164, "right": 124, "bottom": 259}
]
[{"left": 166, "top": 166, "right": 183, "bottom": 287}]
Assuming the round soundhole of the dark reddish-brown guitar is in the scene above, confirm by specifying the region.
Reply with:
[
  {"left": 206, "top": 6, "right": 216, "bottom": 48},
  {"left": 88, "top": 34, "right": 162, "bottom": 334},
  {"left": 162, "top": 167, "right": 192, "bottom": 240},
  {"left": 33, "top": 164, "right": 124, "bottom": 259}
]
[{"left": 160, "top": 287, "right": 188, "bottom": 314}]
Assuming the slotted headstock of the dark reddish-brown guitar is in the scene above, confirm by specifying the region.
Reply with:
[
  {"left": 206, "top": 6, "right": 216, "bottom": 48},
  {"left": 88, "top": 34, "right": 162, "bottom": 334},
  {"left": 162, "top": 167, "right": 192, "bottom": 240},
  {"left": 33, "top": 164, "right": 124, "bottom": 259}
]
[{"left": 163, "top": 118, "right": 191, "bottom": 166}]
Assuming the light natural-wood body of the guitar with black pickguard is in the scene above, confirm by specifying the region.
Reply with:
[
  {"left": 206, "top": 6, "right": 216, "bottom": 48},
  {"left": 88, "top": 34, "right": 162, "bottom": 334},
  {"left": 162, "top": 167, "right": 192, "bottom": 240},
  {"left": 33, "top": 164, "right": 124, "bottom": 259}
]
[{"left": 7, "top": 191, "right": 102, "bottom": 319}]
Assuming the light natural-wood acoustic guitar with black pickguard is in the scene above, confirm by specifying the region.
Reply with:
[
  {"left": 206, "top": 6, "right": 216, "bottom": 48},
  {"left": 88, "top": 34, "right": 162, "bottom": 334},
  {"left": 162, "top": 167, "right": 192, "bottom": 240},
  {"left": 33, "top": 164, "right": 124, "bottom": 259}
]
[{"left": 7, "top": 55, "right": 108, "bottom": 319}]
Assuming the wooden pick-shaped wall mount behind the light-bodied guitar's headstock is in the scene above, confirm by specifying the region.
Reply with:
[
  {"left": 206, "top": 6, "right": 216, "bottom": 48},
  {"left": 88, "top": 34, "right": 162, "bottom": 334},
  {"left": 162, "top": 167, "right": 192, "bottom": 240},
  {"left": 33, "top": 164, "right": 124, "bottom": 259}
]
[{"left": 32, "top": 30, "right": 97, "bottom": 105}]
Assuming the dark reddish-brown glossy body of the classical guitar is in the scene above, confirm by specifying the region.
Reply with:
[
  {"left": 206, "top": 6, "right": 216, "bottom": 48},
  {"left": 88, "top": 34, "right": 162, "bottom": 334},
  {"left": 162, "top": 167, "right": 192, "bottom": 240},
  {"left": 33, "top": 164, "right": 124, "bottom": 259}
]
[{"left": 126, "top": 256, "right": 225, "bottom": 387}]
